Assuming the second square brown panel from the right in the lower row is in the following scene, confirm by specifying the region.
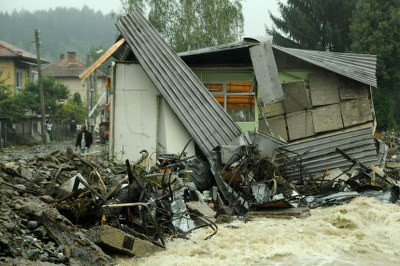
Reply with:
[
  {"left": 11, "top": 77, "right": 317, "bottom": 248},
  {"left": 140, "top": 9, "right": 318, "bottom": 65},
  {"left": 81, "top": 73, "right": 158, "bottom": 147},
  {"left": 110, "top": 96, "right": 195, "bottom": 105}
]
[{"left": 311, "top": 104, "right": 343, "bottom": 133}]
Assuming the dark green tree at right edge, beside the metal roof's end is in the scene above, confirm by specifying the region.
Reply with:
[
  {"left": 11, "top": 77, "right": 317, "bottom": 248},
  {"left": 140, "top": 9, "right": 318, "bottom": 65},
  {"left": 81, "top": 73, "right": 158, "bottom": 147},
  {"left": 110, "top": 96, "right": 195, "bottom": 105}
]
[{"left": 350, "top": 0, "right": 400, "bottom": 129}]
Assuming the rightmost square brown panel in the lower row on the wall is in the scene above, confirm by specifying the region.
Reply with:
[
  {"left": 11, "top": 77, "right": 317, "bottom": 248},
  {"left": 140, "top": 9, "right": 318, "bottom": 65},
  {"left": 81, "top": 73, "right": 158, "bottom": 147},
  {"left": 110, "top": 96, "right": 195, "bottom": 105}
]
[{"left": 340, "top": 98, "right": 374, "bottom": 127}]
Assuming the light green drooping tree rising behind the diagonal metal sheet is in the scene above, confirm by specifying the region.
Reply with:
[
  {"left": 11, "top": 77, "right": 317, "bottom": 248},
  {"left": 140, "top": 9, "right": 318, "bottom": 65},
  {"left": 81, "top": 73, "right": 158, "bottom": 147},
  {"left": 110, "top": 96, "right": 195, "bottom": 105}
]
[{"left": 121, "top": 0, "right": 243, "bottom": 52}]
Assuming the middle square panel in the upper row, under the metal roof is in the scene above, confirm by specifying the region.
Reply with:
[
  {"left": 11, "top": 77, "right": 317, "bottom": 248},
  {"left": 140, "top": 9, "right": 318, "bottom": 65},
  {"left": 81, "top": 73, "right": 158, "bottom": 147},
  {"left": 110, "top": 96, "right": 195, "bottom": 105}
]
[{"left": 310, "top": 72, "right": 340, "bottom": 106}]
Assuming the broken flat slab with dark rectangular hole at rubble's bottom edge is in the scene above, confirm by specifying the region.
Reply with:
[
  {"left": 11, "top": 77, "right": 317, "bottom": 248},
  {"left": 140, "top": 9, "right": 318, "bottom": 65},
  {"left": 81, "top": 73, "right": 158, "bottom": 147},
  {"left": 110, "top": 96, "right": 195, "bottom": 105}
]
[{"left": 88, "top": 225, "right": 163, "bottom": 257}]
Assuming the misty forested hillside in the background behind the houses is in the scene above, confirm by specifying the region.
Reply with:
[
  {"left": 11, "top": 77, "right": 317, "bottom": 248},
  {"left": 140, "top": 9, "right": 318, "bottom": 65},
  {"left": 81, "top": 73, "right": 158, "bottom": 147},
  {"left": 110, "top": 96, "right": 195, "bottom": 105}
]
[{"left": 0, "top": 6, "right": 117, "bottom": 60}]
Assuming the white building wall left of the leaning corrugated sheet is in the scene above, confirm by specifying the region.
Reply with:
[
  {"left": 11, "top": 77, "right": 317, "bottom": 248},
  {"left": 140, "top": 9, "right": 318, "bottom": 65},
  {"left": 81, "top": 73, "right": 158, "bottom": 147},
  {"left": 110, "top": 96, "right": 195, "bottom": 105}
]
[{"left": 110, "top": 63, "right": 194, "bottom": 165}]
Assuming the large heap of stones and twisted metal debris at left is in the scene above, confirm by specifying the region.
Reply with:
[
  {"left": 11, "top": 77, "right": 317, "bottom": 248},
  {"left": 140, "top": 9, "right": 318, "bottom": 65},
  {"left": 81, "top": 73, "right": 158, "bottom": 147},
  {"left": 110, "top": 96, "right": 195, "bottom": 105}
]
[{"left": 0, "top": 149, "right": 217, "bottom": 265}]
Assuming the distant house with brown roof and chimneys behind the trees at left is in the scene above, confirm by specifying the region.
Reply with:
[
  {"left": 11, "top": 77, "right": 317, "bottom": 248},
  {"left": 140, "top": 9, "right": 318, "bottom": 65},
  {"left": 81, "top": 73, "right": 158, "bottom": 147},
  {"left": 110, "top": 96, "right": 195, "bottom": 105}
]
[{"left": 43, "top": 52, "right": 106, "bottom": 102}]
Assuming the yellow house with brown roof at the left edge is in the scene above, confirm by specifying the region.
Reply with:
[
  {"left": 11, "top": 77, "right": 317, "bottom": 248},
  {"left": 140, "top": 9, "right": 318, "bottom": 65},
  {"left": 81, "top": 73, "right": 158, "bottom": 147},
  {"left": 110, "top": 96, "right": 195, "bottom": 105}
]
[{"left": 0, "top": 40, "right": 49, "bottom": 95}]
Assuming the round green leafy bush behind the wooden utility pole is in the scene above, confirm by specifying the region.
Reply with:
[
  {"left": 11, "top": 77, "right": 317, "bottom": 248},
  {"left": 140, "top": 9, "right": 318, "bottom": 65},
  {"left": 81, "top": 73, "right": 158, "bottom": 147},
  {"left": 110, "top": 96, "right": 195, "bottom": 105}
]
[{"left": 21, "top": 78, "right": 69, "bottom": 116}]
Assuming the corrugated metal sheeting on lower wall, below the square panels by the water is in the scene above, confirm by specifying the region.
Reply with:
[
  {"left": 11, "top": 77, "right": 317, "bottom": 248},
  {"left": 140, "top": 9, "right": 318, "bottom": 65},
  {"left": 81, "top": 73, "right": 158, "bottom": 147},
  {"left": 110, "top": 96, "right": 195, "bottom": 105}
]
[{"left": 276, "top": 127, "right": 378, "bottom": 181}]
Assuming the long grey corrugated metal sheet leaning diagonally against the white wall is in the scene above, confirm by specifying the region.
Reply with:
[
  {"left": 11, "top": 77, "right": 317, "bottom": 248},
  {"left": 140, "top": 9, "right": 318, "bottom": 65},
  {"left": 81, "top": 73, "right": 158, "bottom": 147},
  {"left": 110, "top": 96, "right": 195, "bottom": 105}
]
[{"left": 116, "top": 12, "right": 241, "bottom": 155}]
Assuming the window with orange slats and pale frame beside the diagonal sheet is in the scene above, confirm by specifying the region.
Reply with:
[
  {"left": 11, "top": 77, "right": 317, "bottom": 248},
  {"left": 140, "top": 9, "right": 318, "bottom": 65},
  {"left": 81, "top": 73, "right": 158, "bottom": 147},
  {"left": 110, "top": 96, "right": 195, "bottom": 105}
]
[{"left": 204, "top": 81, "right": 255, "bottom": 122}]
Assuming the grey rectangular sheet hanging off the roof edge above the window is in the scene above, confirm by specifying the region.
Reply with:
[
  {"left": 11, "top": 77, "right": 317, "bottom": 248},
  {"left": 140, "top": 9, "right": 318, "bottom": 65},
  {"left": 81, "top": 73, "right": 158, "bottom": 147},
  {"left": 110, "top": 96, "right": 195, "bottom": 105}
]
[{"left": 250, "top": 42, "right": 284, "bottom": 105}]
